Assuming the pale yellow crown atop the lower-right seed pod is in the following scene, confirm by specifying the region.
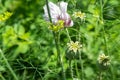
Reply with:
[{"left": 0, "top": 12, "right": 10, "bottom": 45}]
[{"left": 98, "top": 54, "right": 110, "bottom": 66}]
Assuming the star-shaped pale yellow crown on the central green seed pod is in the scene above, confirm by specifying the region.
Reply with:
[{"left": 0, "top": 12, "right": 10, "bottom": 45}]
[{"left": 67, "top": 41, "right": 82, "bottom": 53}]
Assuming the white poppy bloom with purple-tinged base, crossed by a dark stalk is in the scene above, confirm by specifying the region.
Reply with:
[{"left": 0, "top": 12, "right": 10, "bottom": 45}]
[{"left": 43, "top": 1, "right": 73, "bottom": 27}]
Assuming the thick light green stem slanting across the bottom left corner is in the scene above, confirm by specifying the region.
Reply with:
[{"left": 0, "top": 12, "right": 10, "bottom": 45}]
[{"left": 0, "top": 49, "right": 18, "bottom": 80}]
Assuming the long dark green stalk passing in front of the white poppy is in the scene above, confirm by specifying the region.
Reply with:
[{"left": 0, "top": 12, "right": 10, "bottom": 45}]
[{"left": 46, "top": 0, "right": 66, "bottom": 80}]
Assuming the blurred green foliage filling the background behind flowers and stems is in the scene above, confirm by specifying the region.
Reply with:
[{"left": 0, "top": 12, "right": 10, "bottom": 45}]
[{"left": 0, "top": 0, "right": 120, "bottom": 80}]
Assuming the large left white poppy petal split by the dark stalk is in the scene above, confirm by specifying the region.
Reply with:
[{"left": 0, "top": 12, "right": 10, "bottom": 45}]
[{"left": 43, "top": 2, "right": 61, "bottom": 23}]
